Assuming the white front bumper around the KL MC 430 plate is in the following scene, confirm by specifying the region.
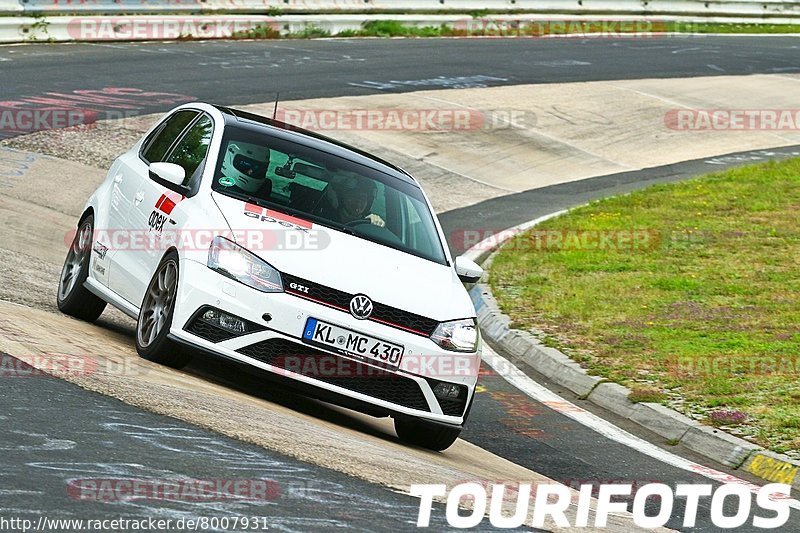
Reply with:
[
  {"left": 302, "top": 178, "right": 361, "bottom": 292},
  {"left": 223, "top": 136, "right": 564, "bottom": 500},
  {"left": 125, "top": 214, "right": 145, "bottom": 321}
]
[{"left": 170, "top": 259, "right": 480, "bottom": 426}]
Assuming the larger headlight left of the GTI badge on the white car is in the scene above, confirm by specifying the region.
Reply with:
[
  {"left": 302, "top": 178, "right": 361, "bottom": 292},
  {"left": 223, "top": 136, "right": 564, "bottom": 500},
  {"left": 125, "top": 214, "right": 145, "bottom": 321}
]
[{"left": 208, "top": 237, "right": 283, "bottom": 292}]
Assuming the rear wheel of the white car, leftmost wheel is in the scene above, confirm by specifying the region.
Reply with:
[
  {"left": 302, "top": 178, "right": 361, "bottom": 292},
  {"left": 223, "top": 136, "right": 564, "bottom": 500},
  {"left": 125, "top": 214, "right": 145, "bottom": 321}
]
[{"left": 56, "top": 215, "right": 106, "bottom": 322}]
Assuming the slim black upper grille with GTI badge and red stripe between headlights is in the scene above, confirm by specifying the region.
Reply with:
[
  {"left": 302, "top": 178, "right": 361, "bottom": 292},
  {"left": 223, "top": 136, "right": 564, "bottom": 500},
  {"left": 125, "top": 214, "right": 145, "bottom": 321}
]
[{"left": 281, "top": 274, "right": 439, "bottom": 337}]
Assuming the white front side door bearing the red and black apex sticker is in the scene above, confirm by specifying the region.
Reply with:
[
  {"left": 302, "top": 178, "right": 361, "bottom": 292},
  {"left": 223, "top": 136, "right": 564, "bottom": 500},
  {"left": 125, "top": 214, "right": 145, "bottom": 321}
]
[{"left": 130, "top": 114, "right": 213, "bottom": 305}]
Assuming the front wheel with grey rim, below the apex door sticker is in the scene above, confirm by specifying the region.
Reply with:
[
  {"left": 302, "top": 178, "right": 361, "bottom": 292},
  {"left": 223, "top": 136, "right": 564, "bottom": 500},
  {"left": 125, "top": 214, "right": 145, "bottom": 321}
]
[{"left": 136, "top": 251, "right": 191, "bottom": 368}]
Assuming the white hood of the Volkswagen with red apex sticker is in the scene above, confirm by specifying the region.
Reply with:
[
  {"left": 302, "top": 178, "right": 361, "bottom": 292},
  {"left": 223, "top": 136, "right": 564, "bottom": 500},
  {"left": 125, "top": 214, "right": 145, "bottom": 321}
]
[{"left": 212, "top": 192, "right": 475, "bottom": 321}]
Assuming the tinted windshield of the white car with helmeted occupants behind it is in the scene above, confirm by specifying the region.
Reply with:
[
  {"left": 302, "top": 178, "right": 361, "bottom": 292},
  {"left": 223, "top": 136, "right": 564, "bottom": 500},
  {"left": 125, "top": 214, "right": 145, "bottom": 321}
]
[{"left": 212, "top": 126, "right": 447, "bottom": 265}]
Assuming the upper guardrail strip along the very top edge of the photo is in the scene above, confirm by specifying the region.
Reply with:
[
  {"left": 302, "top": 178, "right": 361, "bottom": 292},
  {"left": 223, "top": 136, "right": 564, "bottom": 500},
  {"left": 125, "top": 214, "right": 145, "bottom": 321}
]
[{"left": 0, "top": 0, "right": 800, "bottom": 17}]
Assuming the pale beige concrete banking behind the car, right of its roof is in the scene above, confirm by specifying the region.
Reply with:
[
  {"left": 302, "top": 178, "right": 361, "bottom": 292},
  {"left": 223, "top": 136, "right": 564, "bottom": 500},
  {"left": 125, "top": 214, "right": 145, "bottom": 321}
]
[{"left": 238, "top": 75, "right": 800, "bottom": 193}]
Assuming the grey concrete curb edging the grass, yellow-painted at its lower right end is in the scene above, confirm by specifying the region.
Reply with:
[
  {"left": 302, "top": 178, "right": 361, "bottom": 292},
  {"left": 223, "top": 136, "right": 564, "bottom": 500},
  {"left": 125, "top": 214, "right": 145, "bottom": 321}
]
[{"left": 465, "top": 211, "right": 800, "bottom": 490}]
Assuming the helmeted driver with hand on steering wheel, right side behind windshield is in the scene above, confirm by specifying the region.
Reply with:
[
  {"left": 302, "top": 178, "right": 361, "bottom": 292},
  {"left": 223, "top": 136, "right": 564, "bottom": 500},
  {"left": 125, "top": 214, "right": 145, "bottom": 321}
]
[{"left": 324, "top": 172, "right": 386, "bottom": 228}]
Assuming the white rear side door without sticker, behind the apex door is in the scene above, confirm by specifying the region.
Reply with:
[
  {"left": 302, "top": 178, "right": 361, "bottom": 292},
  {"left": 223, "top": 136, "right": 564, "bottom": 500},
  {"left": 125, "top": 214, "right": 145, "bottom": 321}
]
[{"left": 108, "top": 109, "right": 199, "bottom": 307}]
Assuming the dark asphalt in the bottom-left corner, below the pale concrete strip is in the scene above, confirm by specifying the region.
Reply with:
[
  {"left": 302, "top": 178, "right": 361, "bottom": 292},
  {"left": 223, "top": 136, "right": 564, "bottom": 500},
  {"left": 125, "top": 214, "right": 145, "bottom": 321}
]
[{"left": 0, "top": 366, "right": 472, "bottom": 532}]
